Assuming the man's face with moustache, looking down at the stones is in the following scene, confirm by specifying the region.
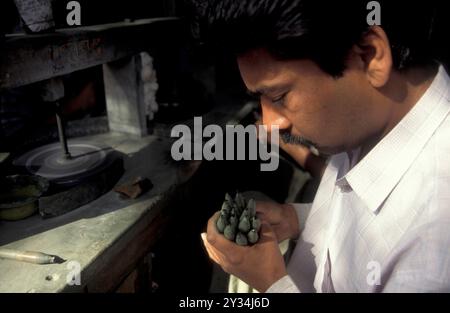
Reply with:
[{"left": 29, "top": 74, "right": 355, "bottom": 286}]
[{"left": 238, "top": 49, "right": 385, "bottom": 154}]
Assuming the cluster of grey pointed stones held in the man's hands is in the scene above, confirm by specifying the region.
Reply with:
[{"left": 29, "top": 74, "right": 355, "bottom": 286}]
[{"left": 216, "top": 192, "right": 261, "bottom": 246}]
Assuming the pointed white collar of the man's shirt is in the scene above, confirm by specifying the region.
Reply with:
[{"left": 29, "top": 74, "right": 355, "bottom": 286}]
[{"left": 337, "top": 65, "right": 450, "bottom": 213}]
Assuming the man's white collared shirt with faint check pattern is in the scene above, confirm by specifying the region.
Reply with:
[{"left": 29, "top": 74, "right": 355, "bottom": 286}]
[{"left": 267, "top": 66, "right": 450, "bottom": 292}]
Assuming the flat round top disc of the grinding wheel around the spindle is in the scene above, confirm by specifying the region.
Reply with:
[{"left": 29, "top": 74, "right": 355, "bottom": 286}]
[{"left": 14, "top": 140, "right": 117, "bottom": 186}]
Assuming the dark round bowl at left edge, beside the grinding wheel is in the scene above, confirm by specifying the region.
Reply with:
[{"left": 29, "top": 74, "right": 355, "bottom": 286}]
[{"left": 0, "top": 175, "right": 49, "bottom": 221}]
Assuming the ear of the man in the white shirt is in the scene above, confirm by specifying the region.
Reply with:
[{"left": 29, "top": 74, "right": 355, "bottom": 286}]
[{"left": 353, "top": 26, "right": 392, "bottom": 88}]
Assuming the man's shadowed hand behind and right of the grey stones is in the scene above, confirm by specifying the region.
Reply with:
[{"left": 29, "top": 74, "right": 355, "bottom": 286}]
[{"left": 256, "top": 201, "right": 300, "bottom": 242}]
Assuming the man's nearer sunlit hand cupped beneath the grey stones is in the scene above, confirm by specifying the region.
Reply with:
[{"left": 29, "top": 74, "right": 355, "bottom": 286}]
[{"left": 202, "top": 212, "right": 286, "bottom": 292}]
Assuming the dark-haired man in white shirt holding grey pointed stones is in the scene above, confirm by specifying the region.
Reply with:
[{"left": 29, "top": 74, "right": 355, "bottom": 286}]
[{"left": 197, "top": 0, "right": 450, "bottom": 292}]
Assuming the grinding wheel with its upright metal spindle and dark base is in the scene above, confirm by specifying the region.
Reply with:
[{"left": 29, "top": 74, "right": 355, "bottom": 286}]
[{"left": 13, "top": 78, "right": 123, "bottom": 217}]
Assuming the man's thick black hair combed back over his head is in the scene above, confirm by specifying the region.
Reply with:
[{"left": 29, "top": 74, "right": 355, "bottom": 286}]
[{"left": 188, "top": 0, "right": 442, "bottom": 77}]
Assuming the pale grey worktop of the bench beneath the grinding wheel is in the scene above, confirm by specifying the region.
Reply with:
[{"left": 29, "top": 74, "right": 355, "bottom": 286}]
[{"left": 0, "top": 133, "right": 177, "bottom": 292}]
